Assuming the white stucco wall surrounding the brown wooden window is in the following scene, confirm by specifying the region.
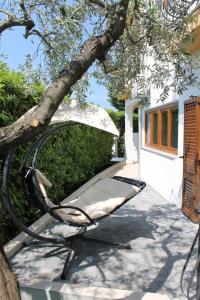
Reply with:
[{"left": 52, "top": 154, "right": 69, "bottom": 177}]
[{"left": 139, "top": 62, "right": 200, "bottom": 207}]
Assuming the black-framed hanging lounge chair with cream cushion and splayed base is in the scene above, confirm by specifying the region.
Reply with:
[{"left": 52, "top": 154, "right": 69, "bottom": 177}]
[{"left": 2, "top": 122, "right": 146, "bottom": 279}]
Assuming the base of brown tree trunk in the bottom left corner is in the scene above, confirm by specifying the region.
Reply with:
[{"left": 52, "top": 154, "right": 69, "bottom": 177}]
[{"left": 0, "top": 246, "right": 21, "bottom": 300}]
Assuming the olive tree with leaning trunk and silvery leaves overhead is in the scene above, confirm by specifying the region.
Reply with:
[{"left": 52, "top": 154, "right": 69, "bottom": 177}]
[{"left": 0, "top": 0, "right": 198, "bottom": 300}]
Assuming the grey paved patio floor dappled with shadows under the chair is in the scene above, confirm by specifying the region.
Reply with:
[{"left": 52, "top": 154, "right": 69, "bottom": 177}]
[{"left": 9, "top": 167, "right": 196, "bottom": 300}]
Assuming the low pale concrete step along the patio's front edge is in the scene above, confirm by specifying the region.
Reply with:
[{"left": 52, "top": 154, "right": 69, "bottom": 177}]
[{"left": 20, "top": 281, "right": 170, "bottom": 300}]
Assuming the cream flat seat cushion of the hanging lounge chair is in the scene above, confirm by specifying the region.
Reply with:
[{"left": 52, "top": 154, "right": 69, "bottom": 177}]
[{"left": 56, "top": 178, "right": 139, "bottom": 224}]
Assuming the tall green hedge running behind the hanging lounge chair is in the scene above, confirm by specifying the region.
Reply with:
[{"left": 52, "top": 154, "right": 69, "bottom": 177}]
[{"left": 0, "top": 63, "right": 113, "bottom": 243}]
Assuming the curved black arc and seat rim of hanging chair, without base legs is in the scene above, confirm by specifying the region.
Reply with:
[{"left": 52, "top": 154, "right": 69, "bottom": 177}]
[{"left": 2, "top": 121, "right": 146, "bottom": 237}]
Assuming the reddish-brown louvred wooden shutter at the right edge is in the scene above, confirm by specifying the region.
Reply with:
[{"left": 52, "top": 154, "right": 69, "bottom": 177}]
[{"left": 182, "top": 97, "right": 200, "bottom": 223}]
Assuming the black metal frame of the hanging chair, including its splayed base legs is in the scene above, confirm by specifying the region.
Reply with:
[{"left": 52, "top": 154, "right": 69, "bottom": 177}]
[{"left": 2, "top": 121, "right": 146, "bottom": 279}]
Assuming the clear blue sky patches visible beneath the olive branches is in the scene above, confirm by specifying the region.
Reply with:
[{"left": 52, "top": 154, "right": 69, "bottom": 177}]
[{"left": 0, "top": 27, "right": 112, "bottom": 108}]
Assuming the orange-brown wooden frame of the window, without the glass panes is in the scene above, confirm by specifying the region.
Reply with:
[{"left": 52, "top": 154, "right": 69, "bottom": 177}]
[{"left": 145, "top": 102, "right": 178, "bottom": 155}]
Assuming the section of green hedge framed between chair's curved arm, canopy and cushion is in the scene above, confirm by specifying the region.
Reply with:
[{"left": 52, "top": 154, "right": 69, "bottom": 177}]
[{"left": 38, "top": 125, "right": 113, "bottom": 200}]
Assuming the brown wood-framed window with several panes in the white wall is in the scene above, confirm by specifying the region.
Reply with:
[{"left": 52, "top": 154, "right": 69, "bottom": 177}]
[{"left": 145, "top": 106, "right": 178, "bottom": 154}]
